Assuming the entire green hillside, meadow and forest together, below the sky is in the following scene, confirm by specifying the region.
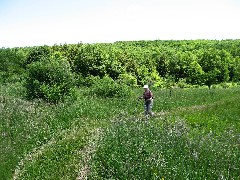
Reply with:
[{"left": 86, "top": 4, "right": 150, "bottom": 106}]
[{"left": 0, "top": 40, "right": 240, "bottom": 180}]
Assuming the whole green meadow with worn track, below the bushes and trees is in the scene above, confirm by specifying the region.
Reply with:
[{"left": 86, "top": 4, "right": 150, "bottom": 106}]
[{"left": 0, "top": 84, "right": 240, "bottom": 180}]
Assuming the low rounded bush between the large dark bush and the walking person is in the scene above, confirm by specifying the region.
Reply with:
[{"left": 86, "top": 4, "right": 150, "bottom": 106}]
[{"left": 91, "top": 77, "right": 133, "bottom": 98}]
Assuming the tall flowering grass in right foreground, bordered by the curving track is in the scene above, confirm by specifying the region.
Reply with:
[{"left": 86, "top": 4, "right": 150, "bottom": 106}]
[{"left": 90, "top": 119, "right": 240, "bottom": 179}]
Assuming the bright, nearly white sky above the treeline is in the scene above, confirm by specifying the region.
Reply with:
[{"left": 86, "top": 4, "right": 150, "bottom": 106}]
[{"left": 0, "top": 0, "right": 240, "bottom": 47}]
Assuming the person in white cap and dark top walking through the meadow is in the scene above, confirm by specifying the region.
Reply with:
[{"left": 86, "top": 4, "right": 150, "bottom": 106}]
[{"left": 139, "top": 85, "right": 154, "bottom": 116}]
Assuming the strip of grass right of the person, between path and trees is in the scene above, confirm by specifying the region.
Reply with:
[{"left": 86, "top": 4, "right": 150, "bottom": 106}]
[{"left": 153, "top": 87, "right": 239, "bottom": 111}]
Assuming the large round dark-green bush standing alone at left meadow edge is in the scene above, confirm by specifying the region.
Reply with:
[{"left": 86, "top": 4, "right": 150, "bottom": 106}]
[{"left": 26, "top": 56, "right": 74, "bottom": 102}]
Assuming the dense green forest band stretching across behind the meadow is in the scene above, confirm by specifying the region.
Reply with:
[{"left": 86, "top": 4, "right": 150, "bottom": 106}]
[{"left": 0, "top": 40, "right": 240, "bottom": 100}]
